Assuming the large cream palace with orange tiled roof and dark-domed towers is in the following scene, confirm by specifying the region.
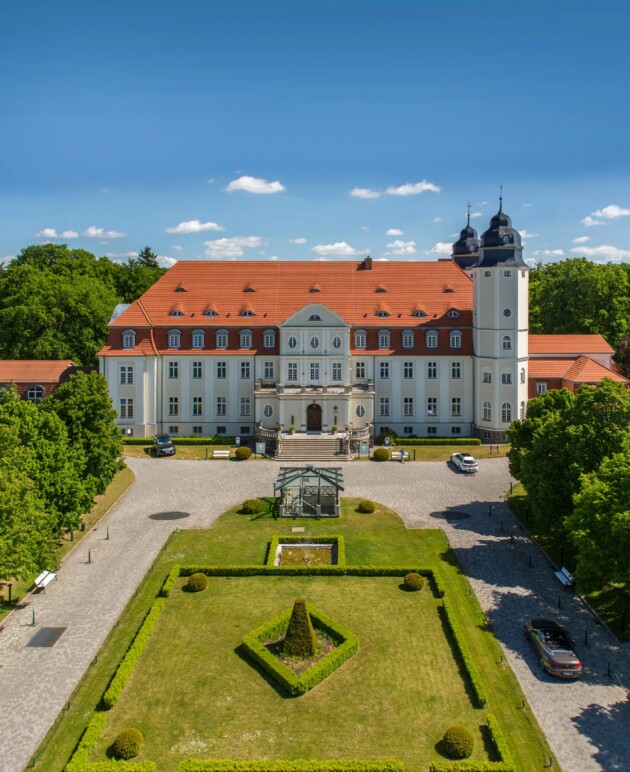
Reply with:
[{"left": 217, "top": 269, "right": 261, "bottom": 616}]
[{"left": 99, "top": 207, "right": 624, "bottom": 442}]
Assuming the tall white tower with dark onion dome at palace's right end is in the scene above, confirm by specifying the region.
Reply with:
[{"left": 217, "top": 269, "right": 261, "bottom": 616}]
[{"left": 470, "top": 196, "right": 529, "bottom": 442}]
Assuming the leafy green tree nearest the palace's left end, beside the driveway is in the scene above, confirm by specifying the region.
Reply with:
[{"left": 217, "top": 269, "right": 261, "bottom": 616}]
[{"left": 42, "top": 372, "right": 122, "bottom": 493}]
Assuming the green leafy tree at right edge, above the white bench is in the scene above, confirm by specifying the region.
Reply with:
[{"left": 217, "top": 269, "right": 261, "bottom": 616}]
[{"left": 567, "top": 441, "right": 630, "bottom": 590}]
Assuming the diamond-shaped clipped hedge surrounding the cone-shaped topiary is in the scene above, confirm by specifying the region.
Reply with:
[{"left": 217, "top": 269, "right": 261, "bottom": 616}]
[{"left": 243, "top": 603, "right": 359, "bottom": 696}]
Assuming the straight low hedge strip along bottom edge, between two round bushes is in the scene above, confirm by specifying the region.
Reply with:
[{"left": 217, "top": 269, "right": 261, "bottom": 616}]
[{"left": 179, "top": 759, "right": 405, "bottom": 772}]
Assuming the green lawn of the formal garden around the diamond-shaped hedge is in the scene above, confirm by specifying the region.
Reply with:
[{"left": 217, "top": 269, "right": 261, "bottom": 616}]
[{"left": 35, "top": 500, "right": 551, "bottom": 772}]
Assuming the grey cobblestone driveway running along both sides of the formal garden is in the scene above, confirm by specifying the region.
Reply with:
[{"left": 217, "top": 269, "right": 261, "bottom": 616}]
[{"left": 0, "top": 459, "right": 630, "bottom": 772}]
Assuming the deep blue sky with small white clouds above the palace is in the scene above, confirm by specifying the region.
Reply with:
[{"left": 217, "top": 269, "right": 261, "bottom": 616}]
[{"left": 0, "top": 0, "right": 630, "bottom": 262}]
